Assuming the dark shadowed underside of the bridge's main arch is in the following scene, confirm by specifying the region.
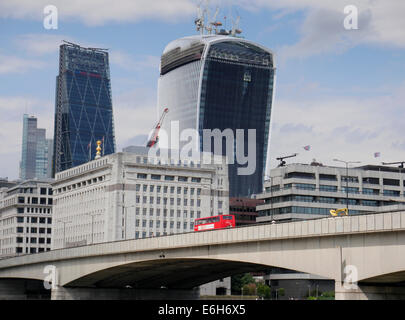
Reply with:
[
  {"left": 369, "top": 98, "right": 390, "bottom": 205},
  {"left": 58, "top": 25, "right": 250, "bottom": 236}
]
[{"left": 65, "top": 255, "right": 271, "bottom": 289}]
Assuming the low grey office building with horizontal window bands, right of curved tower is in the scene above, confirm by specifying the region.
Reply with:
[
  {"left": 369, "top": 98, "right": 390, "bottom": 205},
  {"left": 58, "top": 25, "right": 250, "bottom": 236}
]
[{"left": 257, "top": 163, "right": 405, "bottom": 222}]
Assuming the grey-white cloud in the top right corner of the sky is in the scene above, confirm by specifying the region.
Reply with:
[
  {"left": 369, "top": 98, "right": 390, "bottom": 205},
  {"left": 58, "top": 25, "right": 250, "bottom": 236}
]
[{"left": 238, "top": 0, "right": 405, "bottom": 61}]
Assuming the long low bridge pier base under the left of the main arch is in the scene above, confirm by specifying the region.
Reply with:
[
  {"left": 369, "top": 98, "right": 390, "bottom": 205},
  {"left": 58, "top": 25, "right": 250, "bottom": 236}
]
[{"left": 51, "top": 286, "right": 200, "bottom": 300}]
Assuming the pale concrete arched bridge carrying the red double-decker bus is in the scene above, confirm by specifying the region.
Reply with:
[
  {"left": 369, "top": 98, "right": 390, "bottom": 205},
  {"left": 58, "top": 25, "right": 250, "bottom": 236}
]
[{"left": 0, "top": 212, "right": 405, "bottom": 299}]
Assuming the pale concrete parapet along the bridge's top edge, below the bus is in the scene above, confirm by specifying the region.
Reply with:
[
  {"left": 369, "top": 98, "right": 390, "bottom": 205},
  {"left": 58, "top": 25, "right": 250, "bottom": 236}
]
[{"left": 0, "top": 212, "right": 405, "bottom": 270}]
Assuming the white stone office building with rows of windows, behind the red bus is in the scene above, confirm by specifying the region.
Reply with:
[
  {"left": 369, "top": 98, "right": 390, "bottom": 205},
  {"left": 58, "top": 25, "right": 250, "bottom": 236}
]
[{"left": 52, "top": 153, "right": 229, "bottom": 249}]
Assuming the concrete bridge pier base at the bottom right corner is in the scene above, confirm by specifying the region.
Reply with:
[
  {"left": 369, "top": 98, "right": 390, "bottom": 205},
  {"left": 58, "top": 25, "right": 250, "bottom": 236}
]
[{"left": 335, "top": 281, "right": 405, "bottom": 300}]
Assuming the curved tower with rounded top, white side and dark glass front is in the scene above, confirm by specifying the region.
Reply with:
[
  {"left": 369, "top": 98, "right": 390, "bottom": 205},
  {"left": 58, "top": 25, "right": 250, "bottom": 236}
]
[{"left": 158, "top": 35, "right": 275, "bottom": 197}]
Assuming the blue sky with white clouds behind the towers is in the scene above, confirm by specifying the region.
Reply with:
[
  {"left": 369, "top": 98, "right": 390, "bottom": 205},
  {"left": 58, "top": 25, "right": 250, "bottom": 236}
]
[{"left": 0, "top": 0, "right": 405, "bottom": 179}]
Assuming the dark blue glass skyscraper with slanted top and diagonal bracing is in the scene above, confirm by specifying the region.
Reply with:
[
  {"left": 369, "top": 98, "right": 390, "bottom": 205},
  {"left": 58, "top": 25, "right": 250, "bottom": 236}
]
[{"left": 52, "top": 42, "right": 115, "bottom": 176}]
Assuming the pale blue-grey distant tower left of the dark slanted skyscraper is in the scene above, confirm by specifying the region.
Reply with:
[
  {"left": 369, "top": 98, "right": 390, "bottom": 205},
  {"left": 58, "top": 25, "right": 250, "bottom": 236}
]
[{"left": 20, "top": 114, "right": 52, "bottom": 180}]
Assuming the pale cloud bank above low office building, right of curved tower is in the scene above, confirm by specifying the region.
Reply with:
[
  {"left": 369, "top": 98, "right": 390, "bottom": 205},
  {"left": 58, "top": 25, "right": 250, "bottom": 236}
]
[{"left": 270, "top": 83, "right": 405, "bottom": 171}]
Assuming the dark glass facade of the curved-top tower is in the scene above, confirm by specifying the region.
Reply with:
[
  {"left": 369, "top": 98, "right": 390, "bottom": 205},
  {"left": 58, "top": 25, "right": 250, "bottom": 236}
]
[{"left": 198, "top": 41, "right": 274, "bottom": 197}]
